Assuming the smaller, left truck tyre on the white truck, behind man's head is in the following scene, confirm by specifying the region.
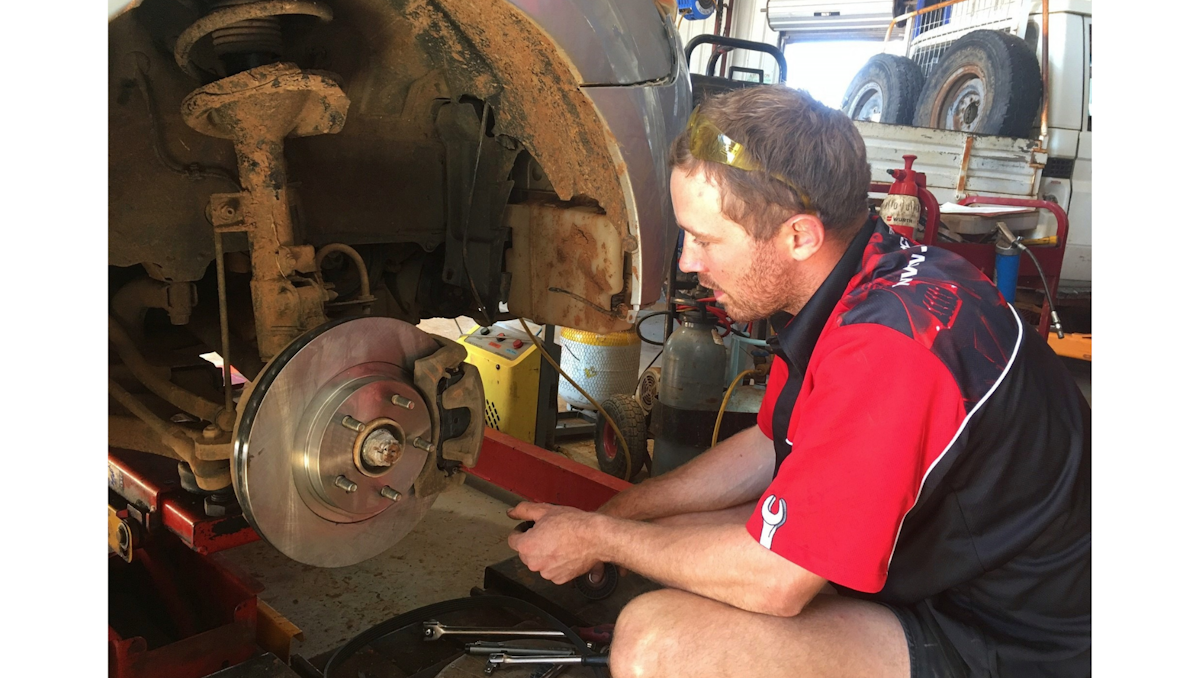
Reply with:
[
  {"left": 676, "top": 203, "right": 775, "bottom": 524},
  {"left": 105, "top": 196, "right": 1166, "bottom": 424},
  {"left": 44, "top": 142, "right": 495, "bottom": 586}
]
[{"left": 841, "top": 54, "right": 925, "bottom": 125}]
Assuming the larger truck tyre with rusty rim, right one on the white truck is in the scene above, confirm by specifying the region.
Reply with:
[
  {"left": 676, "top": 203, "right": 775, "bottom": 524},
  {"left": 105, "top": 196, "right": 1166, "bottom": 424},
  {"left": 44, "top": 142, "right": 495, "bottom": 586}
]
[{"left": 912, "top": 30, "right": 1042, "bottom": 137}]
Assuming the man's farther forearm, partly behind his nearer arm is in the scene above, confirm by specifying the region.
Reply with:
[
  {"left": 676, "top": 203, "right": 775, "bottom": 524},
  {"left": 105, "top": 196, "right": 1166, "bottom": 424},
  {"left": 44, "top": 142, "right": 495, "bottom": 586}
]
[{"left": 600, "top": 426, "right": 775, "bottom": 521}]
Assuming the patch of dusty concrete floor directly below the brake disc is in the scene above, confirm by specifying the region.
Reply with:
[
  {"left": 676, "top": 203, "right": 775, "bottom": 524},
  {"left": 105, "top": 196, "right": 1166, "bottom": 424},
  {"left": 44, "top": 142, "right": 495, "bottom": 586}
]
[{"left": 214, "top": 485, "right": 516, "bottom": 658}]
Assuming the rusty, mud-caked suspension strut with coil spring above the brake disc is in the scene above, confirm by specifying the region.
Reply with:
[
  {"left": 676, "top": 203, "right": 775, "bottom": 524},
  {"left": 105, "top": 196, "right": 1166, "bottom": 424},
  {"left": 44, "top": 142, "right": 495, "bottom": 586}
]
[{"left": 175, "top": 0, "right": 349, "bottom": 360}]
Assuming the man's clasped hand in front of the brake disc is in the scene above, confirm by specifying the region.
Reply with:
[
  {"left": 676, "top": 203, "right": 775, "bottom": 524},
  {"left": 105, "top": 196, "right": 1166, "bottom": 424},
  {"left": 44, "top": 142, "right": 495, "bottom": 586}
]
[{"left": 509, "top": 502, "right": 600, "bottom": 584}]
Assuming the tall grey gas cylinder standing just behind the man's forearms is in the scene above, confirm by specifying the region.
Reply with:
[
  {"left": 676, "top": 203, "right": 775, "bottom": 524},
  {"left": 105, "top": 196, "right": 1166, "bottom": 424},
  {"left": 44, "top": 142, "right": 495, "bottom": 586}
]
[{"left": 650, "top": 308, "right": 728, "bottom": 475}]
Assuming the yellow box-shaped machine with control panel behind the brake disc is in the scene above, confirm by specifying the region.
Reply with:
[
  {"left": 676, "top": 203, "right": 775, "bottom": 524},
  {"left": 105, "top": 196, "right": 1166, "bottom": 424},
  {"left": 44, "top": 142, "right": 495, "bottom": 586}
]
[{"left": 458, "top": 325, "right": 542, "bottom": 443}]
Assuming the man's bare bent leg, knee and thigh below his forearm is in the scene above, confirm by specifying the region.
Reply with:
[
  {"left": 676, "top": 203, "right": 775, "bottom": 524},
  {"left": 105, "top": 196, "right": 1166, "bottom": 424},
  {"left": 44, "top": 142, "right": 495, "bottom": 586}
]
[{"left": 610, "top": 589, "right": 910, "bottom": 678}]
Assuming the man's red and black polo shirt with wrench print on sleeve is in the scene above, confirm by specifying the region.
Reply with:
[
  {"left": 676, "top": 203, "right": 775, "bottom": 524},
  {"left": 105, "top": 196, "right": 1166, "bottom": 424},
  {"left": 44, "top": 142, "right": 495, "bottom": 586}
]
[{"left": 746, "top": 216, "right": 1091, "bottom": 676}]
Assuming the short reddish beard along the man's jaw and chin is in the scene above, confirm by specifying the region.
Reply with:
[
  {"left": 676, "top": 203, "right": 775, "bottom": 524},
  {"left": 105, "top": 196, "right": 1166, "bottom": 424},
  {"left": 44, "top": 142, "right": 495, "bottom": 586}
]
[{"left": 698, "top": 244, "right": 811, "bottom": 323}]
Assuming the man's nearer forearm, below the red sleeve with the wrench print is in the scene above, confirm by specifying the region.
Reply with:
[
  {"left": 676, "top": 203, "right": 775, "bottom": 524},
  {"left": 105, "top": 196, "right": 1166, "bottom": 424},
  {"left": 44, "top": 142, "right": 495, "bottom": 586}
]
[{"left": 594, "top": 516, "right": 824, "bottom": 617}]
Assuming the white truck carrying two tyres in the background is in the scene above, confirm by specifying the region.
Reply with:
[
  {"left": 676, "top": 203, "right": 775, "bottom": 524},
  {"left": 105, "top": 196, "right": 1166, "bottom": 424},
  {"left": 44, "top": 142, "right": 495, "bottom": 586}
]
[{"left": 830, "top": 0, "right": 1092, "bottom": 296}]
